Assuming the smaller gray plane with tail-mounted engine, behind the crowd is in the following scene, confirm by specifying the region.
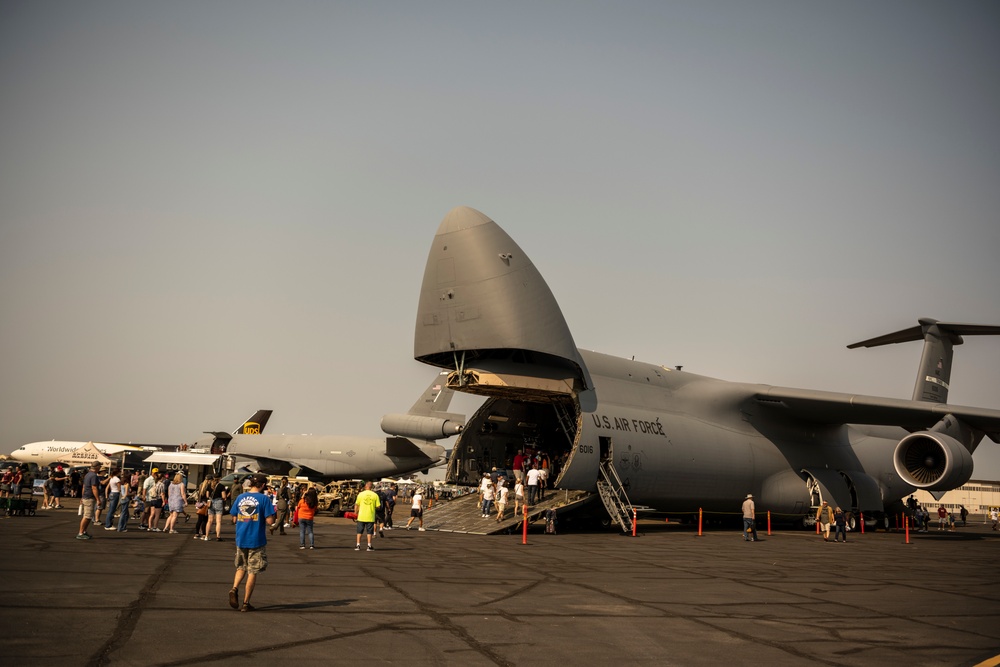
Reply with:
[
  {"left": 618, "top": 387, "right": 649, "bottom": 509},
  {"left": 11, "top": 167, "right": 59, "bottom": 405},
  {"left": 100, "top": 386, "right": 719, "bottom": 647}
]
[{"left": 192, "top": 373, "right": 465, "bottom": 481}]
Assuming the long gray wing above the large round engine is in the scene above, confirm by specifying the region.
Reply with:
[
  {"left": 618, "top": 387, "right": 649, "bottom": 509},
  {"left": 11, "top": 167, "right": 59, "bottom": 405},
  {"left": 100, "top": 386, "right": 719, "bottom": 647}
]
[{"left": 754, "top": 387, "right": 1000, "bottom": 443}]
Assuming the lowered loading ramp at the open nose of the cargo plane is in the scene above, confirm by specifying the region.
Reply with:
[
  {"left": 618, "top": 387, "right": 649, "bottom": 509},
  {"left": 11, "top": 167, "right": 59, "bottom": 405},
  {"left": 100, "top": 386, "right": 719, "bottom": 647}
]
[{"left": 424, "top": 489, "right": 597, "bottom": 535}]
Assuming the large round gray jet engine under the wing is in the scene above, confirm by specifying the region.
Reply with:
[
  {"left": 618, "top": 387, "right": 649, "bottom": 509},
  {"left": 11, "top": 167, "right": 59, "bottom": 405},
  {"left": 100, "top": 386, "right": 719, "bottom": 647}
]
[{"left": 892, "top": 431, "right": 972, "bottom": 491}]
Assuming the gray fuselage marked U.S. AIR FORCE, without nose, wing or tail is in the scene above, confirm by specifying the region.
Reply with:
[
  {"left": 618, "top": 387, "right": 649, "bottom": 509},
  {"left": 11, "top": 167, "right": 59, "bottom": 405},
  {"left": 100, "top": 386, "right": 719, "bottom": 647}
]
[{"left": 449, "top": 350, "right": 913, "bottom": 515}]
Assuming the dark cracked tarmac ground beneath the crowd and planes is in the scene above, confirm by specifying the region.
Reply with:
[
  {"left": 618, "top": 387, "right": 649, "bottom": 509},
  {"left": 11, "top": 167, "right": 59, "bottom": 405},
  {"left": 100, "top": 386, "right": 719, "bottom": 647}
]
[{"left": 0, "top": 499, "right": 1000, "bottom": 667}]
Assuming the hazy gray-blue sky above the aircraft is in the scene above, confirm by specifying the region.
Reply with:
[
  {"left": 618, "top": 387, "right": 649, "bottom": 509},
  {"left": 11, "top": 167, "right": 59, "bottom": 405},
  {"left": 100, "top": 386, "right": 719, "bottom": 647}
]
[{"left": 0, "top": 0, "right": 1000, "bottom": 479}]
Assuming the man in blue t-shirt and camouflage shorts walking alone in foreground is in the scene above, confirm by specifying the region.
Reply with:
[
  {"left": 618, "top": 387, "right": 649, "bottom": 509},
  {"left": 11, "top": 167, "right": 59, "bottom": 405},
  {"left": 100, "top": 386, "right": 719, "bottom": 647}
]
[{"left": 229, "top": 474, "right": 274, "bottom": 611}]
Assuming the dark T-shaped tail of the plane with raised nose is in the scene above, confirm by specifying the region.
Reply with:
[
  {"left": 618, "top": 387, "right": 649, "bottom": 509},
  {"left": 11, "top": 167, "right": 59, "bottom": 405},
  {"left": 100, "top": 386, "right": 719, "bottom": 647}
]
[{"left": 847, "top": 317, "right": 1000, "bottom": 403}]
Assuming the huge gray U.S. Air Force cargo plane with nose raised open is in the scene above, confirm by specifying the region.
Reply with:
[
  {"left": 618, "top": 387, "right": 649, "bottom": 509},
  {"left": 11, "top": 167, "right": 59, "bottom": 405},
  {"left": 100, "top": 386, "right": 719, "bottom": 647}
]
[{"left": 414, "top": 207, "right": 1000, "bottom": 523}]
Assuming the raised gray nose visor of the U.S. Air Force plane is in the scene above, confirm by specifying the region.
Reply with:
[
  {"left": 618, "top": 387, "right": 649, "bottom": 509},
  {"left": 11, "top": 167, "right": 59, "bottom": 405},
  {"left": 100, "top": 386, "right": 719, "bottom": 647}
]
[{"left": 413, "top": 206, "right": 593, "bottom": 400}]
